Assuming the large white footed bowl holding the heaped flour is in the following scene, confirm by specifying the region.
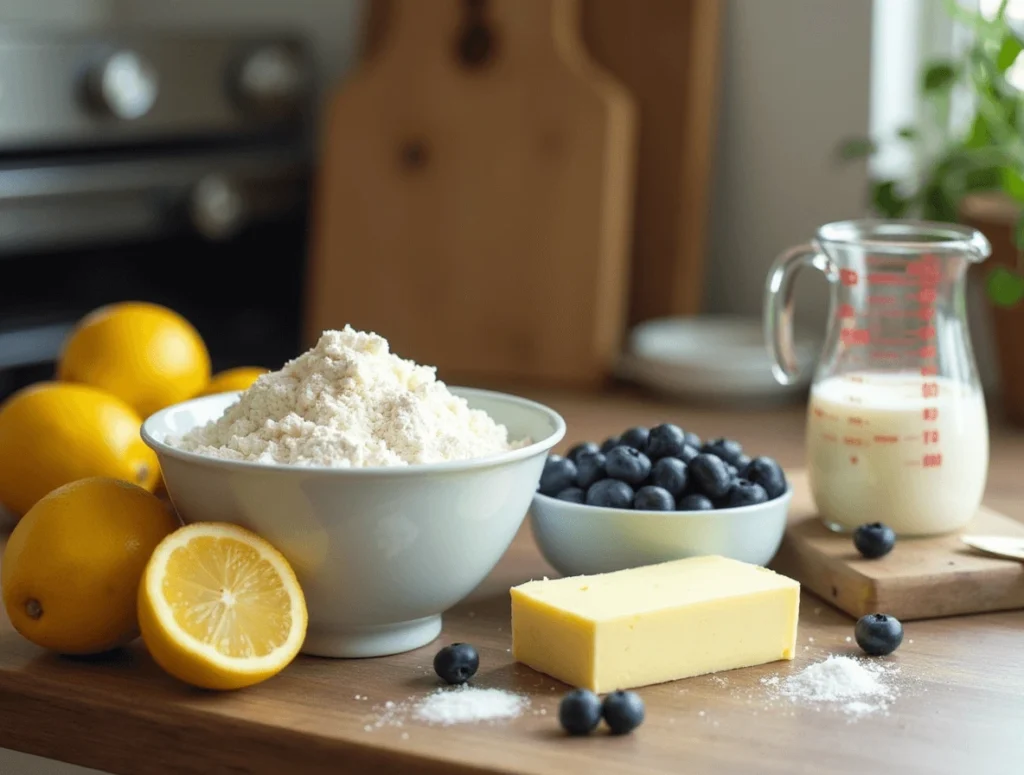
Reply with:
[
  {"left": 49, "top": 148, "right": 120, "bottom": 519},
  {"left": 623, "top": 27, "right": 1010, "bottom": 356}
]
[{"left": 142, "top": 388, "right": 565, "bottom": 657}]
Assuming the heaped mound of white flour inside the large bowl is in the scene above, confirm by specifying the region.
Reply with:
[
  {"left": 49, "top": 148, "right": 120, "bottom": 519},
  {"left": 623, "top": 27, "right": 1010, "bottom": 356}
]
[{"left": 174, "top": 326, "right": 525, "bottom": 468}]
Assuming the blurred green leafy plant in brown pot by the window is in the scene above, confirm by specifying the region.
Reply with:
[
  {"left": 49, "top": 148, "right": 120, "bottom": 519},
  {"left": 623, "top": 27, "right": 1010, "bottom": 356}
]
[{"left": 838, "top": 0, "right": 1024, "bottom": 424}]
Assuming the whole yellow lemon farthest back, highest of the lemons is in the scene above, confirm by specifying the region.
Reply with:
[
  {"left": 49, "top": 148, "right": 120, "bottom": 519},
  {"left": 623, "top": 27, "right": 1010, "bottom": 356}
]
[{"left": 57, "top": 302, "right": 210, "bottom": 419}]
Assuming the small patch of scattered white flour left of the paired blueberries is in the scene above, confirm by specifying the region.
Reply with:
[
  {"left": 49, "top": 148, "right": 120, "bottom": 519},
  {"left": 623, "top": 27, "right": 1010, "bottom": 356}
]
[{"left": 367, "top": 686, "right": 529, "bottom": 731}]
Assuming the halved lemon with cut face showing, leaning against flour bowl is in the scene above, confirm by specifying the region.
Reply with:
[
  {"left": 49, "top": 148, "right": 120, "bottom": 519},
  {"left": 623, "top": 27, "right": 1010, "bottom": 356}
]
[{"left": 138, "top": 522, "right": 306, "bottom": 689}]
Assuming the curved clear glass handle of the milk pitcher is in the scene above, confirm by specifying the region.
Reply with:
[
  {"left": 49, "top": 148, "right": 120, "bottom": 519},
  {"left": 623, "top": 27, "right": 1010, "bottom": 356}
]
[{"left": 764, "top": 243, "right": 839, "bottom": 385}]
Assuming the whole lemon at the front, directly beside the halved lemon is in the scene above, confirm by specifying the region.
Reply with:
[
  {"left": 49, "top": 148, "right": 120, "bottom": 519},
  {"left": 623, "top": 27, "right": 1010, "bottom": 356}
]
[{"left": 0, "top": 477, "right": 178, "bottom": 654}]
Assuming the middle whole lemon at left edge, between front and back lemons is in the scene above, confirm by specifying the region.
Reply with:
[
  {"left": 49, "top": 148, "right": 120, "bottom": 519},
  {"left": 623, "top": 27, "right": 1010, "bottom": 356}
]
[{"left": 0, "top": 382, "right": 159, "bottom": 514}]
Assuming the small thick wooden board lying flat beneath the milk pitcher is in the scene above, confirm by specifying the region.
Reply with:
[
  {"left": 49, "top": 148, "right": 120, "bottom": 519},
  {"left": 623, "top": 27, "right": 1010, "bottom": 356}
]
[{"left": 772, "top": 471, "right": 1024, "bottom": 619}]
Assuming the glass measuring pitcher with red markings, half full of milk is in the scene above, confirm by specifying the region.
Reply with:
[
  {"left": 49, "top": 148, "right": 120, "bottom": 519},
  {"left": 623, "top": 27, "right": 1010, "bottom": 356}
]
[{"left": 765, "top": 220, "right": 991, "bottom": 535}]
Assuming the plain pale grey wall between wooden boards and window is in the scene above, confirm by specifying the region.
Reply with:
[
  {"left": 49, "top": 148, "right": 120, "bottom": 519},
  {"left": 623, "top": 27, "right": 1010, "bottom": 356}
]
[{"left": 705, "top": 0, "right": 871, "bottom": 322}]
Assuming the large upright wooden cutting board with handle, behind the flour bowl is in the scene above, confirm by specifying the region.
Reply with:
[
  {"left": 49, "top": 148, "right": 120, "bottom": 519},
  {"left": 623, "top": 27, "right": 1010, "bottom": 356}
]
[{"left": 306, "top": 0, "right": 636, "bottom": 385}]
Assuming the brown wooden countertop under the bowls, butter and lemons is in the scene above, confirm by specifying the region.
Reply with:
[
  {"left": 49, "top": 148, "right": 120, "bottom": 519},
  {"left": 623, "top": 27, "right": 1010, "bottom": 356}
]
[{"left": 0, "top": 394, "right": 1024, "bottom": 775}]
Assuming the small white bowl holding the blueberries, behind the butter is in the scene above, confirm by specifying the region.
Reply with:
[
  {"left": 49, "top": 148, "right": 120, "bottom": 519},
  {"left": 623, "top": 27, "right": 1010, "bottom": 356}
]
[{"left": 530, "top": 486, "right": 793, "bottom": 575}]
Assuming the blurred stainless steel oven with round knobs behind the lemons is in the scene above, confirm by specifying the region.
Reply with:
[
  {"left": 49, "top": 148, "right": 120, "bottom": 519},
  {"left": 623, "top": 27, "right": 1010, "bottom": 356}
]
[{"left": 0, "top": 27, "right": 313, "bottom": 396}]
